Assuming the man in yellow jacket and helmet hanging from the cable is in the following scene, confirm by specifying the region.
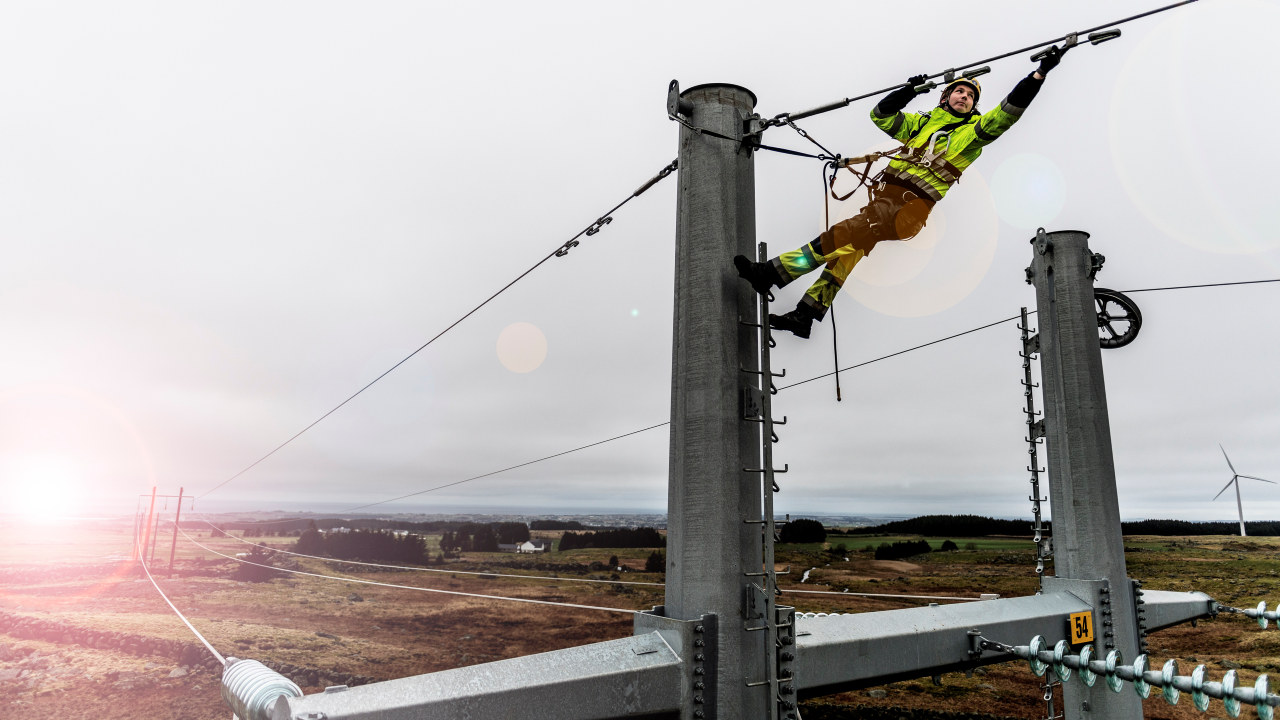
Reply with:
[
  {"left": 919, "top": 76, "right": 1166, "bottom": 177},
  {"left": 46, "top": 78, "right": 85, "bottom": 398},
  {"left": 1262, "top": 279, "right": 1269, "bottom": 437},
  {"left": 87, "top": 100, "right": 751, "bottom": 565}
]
[{"left": 733, "top": 45, "right": 1066, "bottom": 338}]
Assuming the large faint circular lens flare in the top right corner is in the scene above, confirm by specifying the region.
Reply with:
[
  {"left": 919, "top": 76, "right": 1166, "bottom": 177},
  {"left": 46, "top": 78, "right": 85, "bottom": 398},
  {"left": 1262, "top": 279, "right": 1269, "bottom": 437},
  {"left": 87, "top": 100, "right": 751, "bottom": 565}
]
[{"left": 1108, "top": 0, "right": 1280, "bottom": 255}]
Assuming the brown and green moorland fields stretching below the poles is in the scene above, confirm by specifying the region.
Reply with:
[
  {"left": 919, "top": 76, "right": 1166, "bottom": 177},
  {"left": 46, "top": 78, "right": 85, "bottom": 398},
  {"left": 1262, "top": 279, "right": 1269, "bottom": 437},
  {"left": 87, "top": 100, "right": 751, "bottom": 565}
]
[{"left": 0, "top": 515, "right": 1280, "bottom": 720}]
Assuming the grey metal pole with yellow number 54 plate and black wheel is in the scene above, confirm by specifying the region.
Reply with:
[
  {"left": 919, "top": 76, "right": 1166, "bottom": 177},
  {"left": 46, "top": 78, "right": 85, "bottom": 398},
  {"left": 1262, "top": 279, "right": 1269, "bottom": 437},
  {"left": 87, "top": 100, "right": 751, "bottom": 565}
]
[{"left": 1028, "top": 231, "right": 1142, "bottom": 720}]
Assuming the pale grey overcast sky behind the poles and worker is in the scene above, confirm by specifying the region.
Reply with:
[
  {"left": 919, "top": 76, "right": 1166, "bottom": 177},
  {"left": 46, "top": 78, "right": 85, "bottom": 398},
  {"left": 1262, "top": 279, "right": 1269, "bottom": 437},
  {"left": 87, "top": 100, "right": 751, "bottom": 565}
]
[{"left": 0, "top": 0, "right": 1280, "bottom": 520}]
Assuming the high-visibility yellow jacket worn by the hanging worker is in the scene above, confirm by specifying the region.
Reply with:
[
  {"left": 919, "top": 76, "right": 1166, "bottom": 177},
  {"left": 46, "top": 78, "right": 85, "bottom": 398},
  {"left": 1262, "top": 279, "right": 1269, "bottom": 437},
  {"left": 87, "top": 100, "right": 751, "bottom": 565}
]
[{"left": 872, "top": 78, "right": 1039, "bottom": 201}]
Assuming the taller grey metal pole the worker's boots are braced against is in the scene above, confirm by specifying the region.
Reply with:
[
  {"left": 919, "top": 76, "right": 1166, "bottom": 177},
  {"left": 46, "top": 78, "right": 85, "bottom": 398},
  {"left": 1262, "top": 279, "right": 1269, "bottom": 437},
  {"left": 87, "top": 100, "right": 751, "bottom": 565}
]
[{"left": 664, "top": 85, "right": 773, "bottom": 717}]
